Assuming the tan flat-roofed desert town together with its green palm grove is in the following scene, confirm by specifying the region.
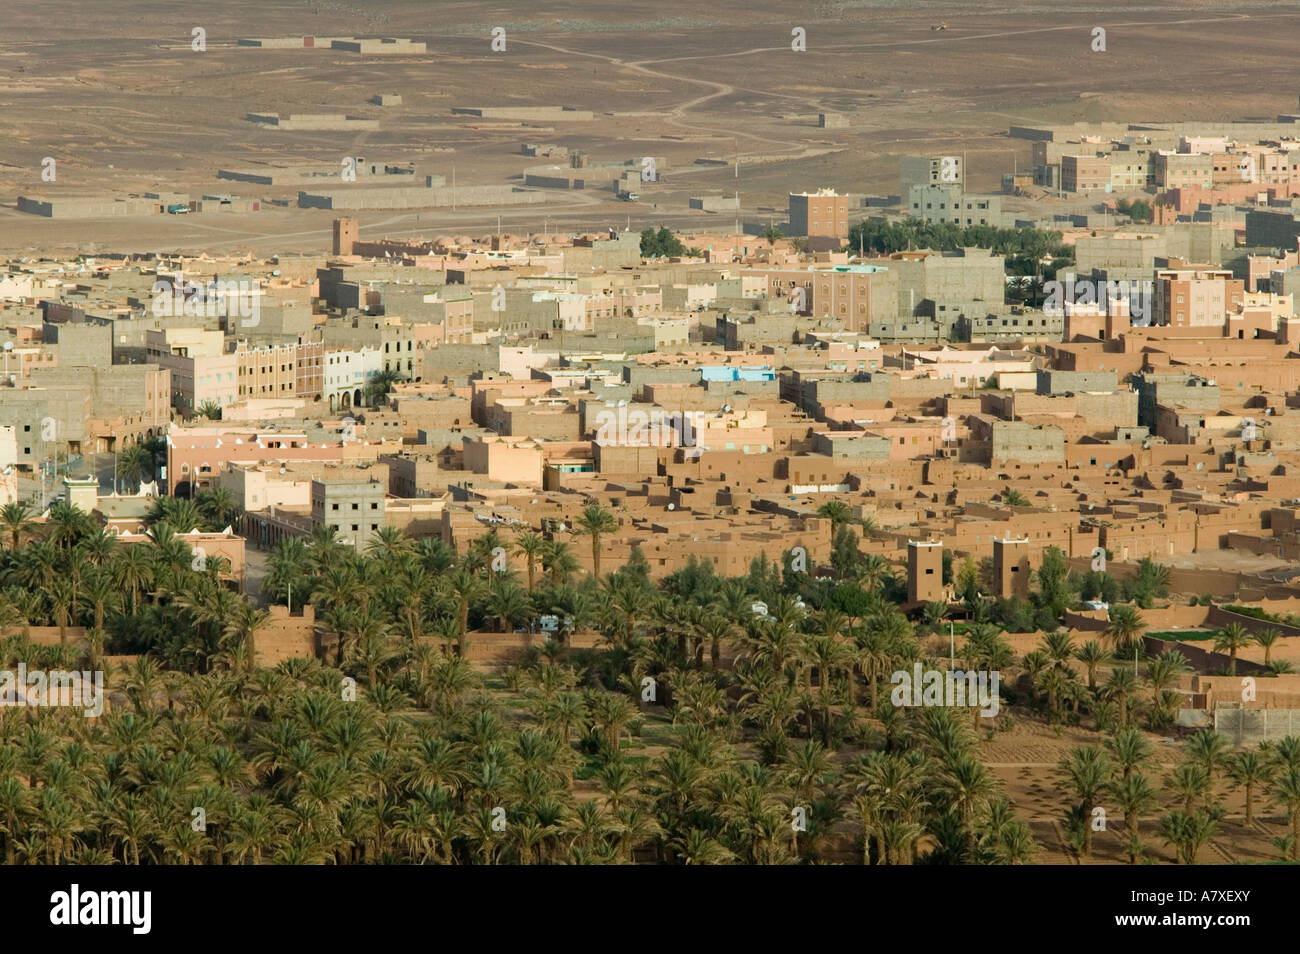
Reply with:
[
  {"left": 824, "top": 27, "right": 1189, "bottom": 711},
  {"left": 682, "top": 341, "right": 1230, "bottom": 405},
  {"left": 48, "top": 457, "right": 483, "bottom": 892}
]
[{"left": 0, "top": 5, "right": 1300, "bottom": 883}]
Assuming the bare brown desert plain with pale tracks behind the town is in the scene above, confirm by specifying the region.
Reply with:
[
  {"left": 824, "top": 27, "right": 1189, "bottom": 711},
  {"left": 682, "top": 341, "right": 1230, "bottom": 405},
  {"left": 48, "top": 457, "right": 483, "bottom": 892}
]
[{"left": 0, "top": 0, "right": 1300, "bottom": 252}]
